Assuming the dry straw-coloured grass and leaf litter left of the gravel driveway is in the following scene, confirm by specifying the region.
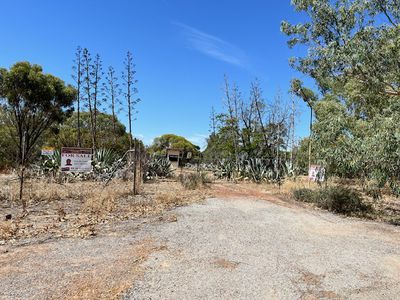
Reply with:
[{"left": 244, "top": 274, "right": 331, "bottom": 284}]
[{"left": 0, "top": 178, "right": 209, "bottom": 244}]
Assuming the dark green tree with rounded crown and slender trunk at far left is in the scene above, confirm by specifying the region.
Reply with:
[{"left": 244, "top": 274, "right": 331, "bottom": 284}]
[{"left": 0, "top": 62, "right": 76, "bottom": 205}]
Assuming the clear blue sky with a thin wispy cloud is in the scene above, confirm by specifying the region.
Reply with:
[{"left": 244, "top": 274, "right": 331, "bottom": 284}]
[{"left": 0, "top": 0, "right": 309, "bottom": 149}]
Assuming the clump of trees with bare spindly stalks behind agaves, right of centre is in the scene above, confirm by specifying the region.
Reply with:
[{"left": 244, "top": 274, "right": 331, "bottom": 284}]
[{"left": 204, "top": 76, "right": 295, "bottom": 182}]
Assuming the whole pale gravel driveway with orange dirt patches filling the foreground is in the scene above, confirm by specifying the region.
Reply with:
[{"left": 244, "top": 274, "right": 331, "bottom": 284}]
[{"left": 0, "top": 198, "right": 400, "bottom": 299}]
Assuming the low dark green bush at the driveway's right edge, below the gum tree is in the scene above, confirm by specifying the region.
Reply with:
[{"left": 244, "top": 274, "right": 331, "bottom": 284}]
[{"left": 293, "top": 186, "right": 372, "bottom": 215}]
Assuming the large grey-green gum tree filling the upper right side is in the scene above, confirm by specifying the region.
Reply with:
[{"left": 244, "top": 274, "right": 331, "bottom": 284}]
[{"left": 281, "top": 0, "right": 400, "bottom": 194}]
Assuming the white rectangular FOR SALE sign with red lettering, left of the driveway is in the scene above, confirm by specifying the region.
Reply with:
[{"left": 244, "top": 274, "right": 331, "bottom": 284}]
[{"left": 61, "top": 147, "right": 92, "bottom": 172}]
